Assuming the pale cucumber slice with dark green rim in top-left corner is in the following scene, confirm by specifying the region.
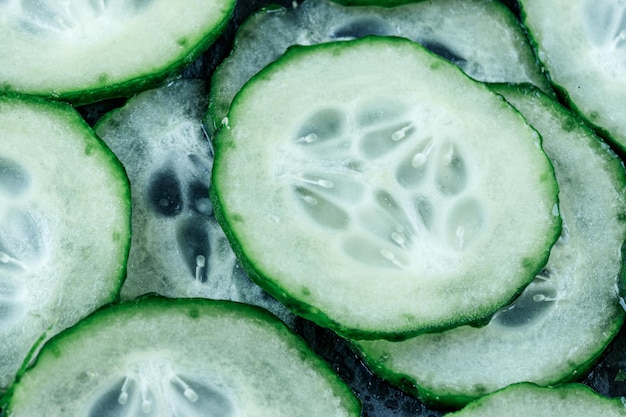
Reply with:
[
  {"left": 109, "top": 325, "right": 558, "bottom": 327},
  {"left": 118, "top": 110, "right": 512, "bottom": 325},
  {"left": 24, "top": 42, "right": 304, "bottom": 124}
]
[{"left": 0, "top": 0, "right": 235, "bottom": 104}]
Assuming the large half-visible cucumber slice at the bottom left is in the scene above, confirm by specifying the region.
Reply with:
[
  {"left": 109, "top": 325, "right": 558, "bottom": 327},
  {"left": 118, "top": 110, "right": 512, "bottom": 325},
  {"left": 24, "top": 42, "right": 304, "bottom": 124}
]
[{"left": 6, "top": 297, "right": 360, "bottom": 417}]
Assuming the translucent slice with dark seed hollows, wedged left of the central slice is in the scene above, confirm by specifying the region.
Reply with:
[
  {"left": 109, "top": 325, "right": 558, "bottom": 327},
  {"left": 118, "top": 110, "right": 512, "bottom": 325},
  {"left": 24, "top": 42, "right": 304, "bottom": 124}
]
[{"left": 94, "top": 79, "right": 293, "bottom": 321}]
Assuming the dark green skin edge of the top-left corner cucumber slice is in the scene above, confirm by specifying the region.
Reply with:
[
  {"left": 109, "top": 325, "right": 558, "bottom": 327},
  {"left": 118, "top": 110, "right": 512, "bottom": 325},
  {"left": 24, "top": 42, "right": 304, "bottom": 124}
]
[{"left": 0, "top": 1, "right": 236, "bottom": 106}]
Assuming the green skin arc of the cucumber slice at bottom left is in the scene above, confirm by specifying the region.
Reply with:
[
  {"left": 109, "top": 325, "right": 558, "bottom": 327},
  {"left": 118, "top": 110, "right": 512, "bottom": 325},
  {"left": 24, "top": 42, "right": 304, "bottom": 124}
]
[{"left": 0, "top": 295, "right": 361, "bottom": 417}]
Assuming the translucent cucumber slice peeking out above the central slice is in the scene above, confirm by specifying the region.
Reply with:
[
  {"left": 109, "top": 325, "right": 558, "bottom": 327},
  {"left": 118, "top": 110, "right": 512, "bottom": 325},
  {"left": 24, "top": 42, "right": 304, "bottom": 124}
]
[{"left": 207, "top": 0, "right": 551, "bottom": 129}]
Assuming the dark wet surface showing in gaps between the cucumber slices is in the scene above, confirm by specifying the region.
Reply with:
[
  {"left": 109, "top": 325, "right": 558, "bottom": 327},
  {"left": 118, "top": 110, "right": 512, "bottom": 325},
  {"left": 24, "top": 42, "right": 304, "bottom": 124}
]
[{"left": 54, "top": 0, "right": 626, "bottom": 417}]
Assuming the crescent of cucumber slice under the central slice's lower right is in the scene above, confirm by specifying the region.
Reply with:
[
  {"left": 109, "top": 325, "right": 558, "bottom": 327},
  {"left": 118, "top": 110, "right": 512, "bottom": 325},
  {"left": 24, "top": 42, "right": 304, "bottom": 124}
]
[{"left": 355, "top": 86, "right": 626, "bottom": 406}]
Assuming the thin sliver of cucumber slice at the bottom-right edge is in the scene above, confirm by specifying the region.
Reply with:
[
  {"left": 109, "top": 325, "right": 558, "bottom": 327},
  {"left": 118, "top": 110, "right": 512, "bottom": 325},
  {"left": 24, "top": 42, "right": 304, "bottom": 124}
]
[{"left": 445, "top": 383, "right": 626, "bottom": 417}]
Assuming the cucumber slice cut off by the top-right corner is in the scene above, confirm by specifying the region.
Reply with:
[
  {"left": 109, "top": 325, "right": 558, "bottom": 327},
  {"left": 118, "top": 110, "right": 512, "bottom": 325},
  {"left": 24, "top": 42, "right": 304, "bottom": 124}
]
[{"left": 520, "top": 0, "right": 626, "bottom": 150}]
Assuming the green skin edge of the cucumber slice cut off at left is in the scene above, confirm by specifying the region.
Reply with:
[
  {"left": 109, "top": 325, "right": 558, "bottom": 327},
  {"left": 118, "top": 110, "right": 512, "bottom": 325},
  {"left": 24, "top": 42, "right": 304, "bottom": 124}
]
[{"left": 0, "top": 93, "right": 131, "bottom": 393}]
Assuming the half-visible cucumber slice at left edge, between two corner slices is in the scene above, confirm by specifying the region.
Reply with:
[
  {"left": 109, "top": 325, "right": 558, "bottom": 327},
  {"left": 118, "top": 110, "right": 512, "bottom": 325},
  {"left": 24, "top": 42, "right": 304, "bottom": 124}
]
[{"left": 0, "top": 96, "right": 130, "bottom": 391}]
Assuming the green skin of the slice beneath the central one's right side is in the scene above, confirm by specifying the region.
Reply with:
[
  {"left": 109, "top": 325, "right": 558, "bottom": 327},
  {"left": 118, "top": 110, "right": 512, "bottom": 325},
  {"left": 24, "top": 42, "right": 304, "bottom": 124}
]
[{"left": 351, "top": 84, "right": 626, "bottom": 408}]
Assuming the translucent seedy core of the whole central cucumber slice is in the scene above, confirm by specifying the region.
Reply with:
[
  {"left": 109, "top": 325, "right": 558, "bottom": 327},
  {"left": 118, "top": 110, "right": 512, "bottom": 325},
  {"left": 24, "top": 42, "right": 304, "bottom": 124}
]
[{"left": 284, "top": 99, "right": 488, "bottom": 269}]
